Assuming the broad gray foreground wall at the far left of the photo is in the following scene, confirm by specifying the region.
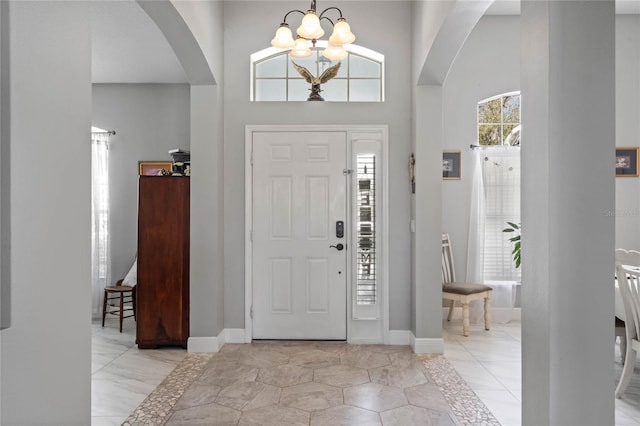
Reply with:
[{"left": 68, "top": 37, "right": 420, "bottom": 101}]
[{"left": 0, "top": 1, "right": 91, "bottom": 426}]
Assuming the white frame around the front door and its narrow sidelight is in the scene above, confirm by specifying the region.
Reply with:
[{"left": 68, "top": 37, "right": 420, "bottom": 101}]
[{"left": 244, "top": 125, "right": 389, "bottom": 344}]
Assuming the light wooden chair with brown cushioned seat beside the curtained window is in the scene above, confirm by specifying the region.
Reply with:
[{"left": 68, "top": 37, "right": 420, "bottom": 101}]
[{"left": 442, "top": 234, "right": 493, "bottom": 337}]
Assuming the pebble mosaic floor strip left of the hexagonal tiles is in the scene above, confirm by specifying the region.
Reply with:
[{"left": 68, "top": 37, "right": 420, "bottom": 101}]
[{"left": 122, "top": 353, "right": 213, "bottom": 426}]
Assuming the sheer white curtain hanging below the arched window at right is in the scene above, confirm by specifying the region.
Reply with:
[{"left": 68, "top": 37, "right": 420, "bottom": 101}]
[{"left": 467, "top": 146, "right": 520, "bottom": 323}]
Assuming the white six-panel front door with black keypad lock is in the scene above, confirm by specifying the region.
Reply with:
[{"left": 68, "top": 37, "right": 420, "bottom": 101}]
[{"left": 252, "top": 131, "right": 348, "bottom": 340}]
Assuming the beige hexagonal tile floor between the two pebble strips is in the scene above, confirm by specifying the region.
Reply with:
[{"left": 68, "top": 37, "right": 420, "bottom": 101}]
[{"left": 160, "top": 342, "right": 460, "bottom": 426}]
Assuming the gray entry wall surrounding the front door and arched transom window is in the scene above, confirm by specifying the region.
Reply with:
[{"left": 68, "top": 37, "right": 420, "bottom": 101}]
[{"left": 224, "top": 1, "right": 411, "bottom": 330}]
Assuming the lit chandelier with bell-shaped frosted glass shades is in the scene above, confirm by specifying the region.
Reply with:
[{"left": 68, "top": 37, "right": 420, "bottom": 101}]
[{"left": 271, "top": 0, "right": 356, "bottom": 59}]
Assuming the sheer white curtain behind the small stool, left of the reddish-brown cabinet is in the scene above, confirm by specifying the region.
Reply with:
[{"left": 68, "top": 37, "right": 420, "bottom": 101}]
[{"left": 91, "top": 132, "right": 111, "bottom": 318}]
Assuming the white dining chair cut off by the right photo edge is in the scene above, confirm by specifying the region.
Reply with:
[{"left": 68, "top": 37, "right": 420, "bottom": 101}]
[{"left": 616, "top": 249, "right": 640, "bottom": 398}]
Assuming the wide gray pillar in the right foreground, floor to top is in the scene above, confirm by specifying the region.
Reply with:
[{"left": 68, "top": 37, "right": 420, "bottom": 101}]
[{"left": 520, "top": 1, "right": 616, "bottom": 425}]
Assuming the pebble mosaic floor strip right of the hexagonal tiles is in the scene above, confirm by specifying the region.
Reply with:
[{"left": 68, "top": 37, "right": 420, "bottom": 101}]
[{"left": 420, "top": 355, "right": 500, "bottom": 426}]
